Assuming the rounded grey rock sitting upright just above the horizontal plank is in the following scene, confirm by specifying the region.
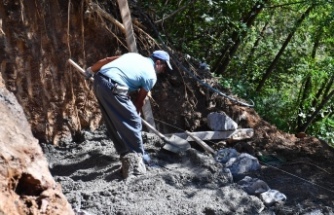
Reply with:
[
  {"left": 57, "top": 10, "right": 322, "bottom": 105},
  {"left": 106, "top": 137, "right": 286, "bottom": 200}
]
[{"left": 207, "top": 112, "right": 238, "bottom": 131}]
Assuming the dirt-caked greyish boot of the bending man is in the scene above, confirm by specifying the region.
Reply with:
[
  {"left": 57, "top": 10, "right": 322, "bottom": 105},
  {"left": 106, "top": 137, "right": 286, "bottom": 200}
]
[{"left": 121, "top": 153, "right": 146, "bottom": 178}]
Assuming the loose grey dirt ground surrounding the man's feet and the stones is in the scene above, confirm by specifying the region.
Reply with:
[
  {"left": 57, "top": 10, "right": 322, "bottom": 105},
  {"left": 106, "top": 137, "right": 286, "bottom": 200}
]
[{"left": 42, "top": 120, "right": 334, "bottom": 215}]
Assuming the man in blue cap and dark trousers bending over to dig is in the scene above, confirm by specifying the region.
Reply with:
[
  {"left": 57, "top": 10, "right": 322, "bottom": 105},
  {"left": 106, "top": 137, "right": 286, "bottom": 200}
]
[{"left": 86, "top": 50, "right": 172, "bottom": 178}]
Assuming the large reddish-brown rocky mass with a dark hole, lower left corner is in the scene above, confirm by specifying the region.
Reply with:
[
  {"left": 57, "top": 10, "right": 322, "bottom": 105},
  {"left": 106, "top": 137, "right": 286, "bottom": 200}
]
[{"left": 0, "top": 87, "right": 74, "bottom": 215}]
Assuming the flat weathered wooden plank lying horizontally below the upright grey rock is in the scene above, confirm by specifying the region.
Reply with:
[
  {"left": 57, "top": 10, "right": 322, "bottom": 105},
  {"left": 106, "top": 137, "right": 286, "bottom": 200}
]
[{"left": 165, "top": 128, "right": 254, "bottom": 141}]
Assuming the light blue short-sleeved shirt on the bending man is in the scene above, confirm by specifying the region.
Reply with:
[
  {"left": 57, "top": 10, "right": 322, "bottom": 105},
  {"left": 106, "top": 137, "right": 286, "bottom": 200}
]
[{"left": 100, "top": 52, "right": 157, "bottom": 91}]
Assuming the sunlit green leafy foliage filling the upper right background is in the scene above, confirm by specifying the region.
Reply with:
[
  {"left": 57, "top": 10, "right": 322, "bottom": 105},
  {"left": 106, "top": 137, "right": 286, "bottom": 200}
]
[{"left": 141, "top": 0, "right": 334, "bottom": 146}]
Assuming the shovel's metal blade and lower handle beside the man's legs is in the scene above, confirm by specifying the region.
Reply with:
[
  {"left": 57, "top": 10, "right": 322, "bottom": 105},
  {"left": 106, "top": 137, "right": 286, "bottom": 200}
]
[{"left": 141, "top": 118, "right": 191, "bottom": 153}]
